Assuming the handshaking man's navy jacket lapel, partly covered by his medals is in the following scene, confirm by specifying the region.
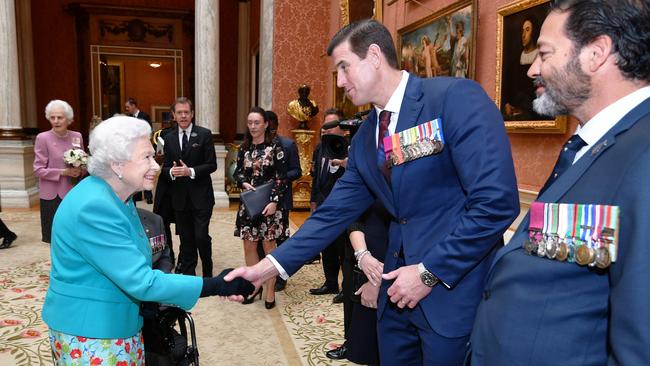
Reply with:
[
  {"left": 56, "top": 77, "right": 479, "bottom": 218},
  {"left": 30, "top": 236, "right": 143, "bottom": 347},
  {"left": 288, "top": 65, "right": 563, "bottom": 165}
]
[{"left": 391, "top": 76, "right": 424, "bottom": 206}]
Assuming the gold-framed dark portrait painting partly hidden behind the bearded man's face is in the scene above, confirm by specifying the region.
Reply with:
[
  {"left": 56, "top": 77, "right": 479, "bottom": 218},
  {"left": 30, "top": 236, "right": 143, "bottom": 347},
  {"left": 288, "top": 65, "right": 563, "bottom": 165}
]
[{"left": 496, "top": 0, "right": 567, "bottom": 133}]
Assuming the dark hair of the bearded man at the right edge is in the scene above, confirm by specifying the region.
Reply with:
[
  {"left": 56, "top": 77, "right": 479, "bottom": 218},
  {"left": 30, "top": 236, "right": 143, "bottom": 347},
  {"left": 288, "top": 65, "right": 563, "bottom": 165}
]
[{"left": 551, "top": 0, "right": 650, "bottom": 81}]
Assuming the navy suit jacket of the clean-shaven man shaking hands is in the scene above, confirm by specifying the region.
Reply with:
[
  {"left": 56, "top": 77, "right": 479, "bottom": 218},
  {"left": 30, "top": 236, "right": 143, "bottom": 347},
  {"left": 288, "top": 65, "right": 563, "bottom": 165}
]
[{"left": 273, "top": 75, "right": 519, "bottom": 337}]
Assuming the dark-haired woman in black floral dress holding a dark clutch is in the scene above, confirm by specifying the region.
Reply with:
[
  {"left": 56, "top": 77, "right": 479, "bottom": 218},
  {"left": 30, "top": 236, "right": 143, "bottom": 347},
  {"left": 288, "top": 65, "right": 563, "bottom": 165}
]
[{"left": 234, "top": 107, "right": 288, "bottom": 309}]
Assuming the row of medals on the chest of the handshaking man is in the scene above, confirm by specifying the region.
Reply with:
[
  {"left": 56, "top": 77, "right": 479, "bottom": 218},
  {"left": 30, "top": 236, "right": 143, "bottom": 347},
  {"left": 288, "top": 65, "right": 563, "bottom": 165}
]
[{"left": 384, "top": 118, "right": 444, "bottom": 166}]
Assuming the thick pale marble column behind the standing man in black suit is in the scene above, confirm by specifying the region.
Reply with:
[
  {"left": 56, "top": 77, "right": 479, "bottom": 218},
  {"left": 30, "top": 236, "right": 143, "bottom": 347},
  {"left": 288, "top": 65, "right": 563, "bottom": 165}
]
[{"left": 194, "top": 0, "right": 230, "bottom": 207}]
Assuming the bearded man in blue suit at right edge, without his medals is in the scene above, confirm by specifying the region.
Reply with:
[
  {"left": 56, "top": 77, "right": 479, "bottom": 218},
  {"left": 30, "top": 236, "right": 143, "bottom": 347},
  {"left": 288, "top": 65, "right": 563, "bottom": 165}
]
[{"left": 471, "top": 0, "right": 650, "bottom": 366}]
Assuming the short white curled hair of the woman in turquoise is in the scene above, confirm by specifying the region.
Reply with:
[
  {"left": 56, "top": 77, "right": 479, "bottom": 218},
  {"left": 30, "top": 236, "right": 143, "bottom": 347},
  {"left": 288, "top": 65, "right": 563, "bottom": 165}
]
[{"left": 88, "top": 116, "right": 151, "bottom": 179}]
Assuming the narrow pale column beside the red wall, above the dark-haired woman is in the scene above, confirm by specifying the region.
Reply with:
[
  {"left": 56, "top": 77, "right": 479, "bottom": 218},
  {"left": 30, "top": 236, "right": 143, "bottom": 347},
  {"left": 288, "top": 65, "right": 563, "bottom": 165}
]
[{"left": 258, "top": 0, "right": 275, "bottom": 109}]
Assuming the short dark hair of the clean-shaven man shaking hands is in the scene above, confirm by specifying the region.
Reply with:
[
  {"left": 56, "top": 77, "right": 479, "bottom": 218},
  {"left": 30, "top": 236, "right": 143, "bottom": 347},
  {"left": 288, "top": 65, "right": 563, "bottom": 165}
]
[{"left": 327, "top": 19, "right": 399, "bottom": 69}]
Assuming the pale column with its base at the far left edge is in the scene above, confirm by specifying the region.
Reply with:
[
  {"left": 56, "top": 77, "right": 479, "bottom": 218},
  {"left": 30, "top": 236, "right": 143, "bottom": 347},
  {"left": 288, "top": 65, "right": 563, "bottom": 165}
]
[{"left": 0, "top": 0, "right": 38, "bottom": 208}]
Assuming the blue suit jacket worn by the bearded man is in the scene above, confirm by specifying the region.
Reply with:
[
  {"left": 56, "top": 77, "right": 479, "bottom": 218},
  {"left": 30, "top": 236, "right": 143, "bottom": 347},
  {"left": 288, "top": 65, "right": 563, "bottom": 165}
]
[{"left": 471, "top": 99, "right": 650, "bottom": 366}]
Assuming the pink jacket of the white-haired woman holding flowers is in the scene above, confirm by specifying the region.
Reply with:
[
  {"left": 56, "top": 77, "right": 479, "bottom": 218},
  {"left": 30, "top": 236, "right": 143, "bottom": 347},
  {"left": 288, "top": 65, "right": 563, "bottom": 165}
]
[{"left": 34, "top": 130, "right": 85, "bottom": 200}]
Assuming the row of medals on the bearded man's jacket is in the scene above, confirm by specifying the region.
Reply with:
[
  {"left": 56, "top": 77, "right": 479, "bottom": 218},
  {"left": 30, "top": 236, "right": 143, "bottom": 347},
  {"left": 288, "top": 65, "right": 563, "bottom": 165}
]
[{"left": 523, "top": 202, "right": 620, "bottom": 268}]
